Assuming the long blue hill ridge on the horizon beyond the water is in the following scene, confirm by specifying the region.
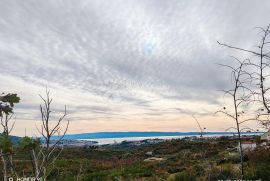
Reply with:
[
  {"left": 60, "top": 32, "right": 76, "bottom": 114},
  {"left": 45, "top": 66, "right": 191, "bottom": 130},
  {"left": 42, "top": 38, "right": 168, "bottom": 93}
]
[{"left": 51, "top": 132, "right": 264, "bottom": 140}]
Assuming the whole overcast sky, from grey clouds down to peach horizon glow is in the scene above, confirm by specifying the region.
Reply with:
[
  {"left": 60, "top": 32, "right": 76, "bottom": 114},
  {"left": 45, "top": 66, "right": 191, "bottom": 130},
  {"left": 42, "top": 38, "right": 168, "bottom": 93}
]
[{"left": 0, "top": 0, "right": 270, "bottom": 135}]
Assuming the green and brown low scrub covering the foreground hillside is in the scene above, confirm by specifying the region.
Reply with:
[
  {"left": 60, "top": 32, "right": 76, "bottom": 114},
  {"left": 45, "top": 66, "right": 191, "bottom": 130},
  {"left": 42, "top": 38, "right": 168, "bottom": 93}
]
[{"left": 0, "top": 137, "right": 270, "bottom": 181}]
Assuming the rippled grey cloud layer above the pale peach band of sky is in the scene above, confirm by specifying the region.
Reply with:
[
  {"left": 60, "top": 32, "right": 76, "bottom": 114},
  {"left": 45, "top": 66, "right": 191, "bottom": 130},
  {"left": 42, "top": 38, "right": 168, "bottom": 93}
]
[{"left": 0, "top": 0, "right": 270, "bottom": 124}]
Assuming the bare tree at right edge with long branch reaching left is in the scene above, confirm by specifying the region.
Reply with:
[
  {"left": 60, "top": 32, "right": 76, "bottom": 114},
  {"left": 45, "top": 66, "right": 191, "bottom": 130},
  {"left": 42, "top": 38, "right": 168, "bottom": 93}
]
[{"left": 218, "top": 25, "right": 270, "bottom": 130}]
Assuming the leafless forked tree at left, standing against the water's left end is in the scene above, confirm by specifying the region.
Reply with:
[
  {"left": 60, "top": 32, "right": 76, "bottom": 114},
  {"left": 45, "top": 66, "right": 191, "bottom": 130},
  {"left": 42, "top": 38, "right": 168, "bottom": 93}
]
[{"left": 31, "top": 88, "right": 69, "bottom": 179}]
